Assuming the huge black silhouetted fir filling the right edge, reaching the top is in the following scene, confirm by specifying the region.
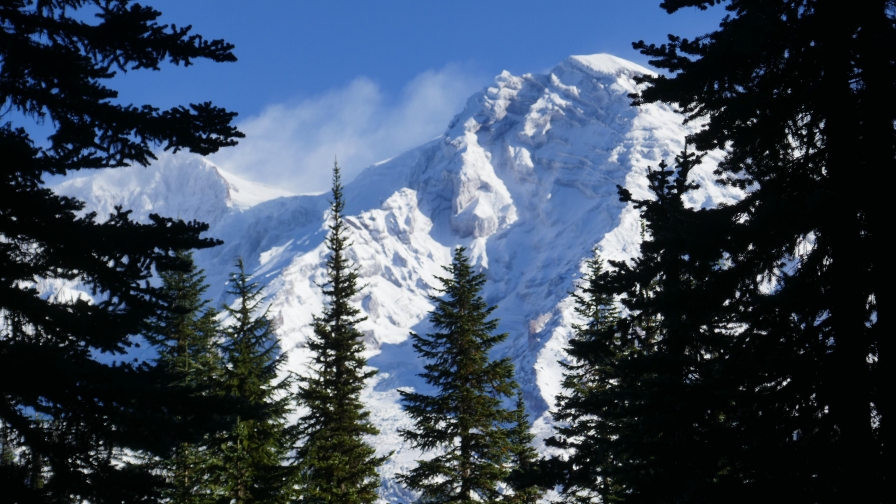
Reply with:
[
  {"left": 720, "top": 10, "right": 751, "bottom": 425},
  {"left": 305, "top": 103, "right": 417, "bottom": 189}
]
[{"left": 636, "top": 0, "right": 896, "bottom": 502}]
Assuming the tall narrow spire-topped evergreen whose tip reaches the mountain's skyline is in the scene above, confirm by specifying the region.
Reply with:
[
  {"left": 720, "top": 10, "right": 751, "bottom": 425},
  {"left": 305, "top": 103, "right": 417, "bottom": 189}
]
[{"left": 296, "top": 164, "right": 388, "bottom": 504}]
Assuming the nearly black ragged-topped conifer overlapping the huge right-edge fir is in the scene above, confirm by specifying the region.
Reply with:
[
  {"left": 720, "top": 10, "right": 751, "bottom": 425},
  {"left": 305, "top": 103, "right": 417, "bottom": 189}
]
[{"left": 608, "top": 155, "right": 736, "bottom": 502}]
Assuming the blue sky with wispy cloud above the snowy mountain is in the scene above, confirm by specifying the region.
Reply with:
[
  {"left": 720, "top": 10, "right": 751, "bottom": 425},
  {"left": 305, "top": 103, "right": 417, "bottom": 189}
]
[{"left": 77, "top": 0, "right": 724, "bottom": 192}]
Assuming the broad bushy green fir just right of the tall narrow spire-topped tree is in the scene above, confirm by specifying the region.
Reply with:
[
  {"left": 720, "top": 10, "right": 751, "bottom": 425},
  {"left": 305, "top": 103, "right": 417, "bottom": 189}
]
[{"left": 398, "top": 247, "right": 520, "bottom": 503}]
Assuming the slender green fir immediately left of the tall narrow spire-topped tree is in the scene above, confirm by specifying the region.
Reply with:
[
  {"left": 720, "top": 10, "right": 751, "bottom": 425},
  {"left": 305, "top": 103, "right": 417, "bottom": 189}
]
[{"left": 213, "top": 259, "right": 295, "bottom": 504}]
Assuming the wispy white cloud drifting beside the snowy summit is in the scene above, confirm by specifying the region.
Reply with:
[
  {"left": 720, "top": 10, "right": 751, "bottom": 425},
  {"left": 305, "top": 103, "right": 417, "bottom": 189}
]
[{"left": 210, "top": 65, "right": 488, "bottom": 193}]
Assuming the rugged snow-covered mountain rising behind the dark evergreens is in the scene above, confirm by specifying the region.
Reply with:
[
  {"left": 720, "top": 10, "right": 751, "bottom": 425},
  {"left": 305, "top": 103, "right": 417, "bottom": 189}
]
[{"left": 56, "top": 54, "right": 738, "bottom": 502}]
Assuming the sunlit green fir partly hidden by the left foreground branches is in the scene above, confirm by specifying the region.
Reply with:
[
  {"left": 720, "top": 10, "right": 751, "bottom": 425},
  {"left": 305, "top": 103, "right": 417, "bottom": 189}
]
[{"left": 144, "top": 251, "right": 222, "bottom": 504}]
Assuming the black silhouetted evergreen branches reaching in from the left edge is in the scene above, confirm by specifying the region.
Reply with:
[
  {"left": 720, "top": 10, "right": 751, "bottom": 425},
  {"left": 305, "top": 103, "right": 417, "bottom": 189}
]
[{"left": 0, "top": 0, "right": 241, "bottom": 503}]
